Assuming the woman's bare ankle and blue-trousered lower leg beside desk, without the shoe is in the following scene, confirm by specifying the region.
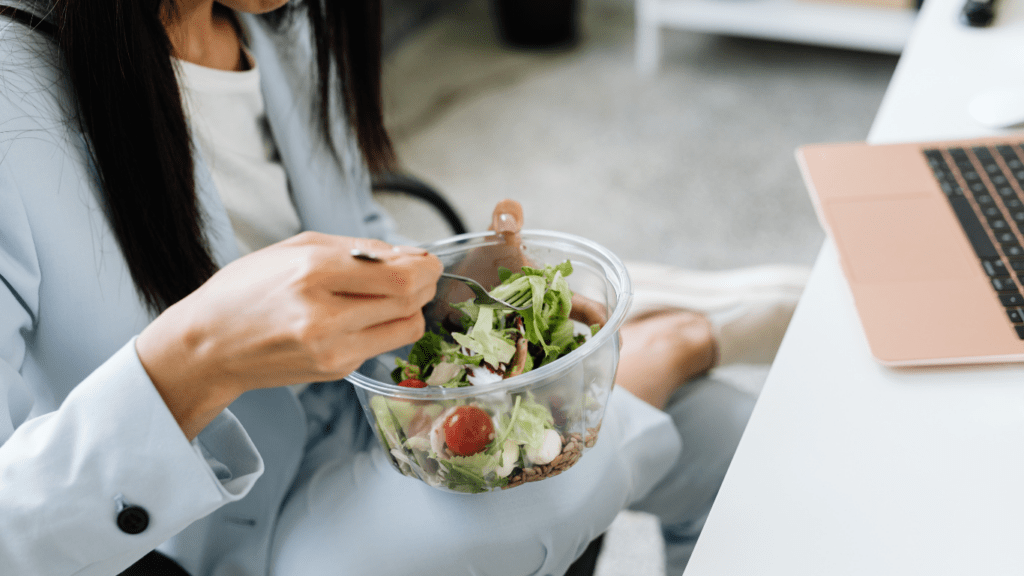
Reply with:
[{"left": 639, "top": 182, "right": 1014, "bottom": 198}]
[{"left": 602, "top": 311, "right": 755, "bottom": 575}]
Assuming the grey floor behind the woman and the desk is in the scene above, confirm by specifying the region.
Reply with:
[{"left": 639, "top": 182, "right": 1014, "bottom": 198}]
[{"left": 385, "top": 0, "right": 896, "bottom": 576}]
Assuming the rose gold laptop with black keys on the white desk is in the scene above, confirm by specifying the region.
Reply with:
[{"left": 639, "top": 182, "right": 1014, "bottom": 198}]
[{"left": 797, "top": 134, "right": 1024, "bottom": 366}]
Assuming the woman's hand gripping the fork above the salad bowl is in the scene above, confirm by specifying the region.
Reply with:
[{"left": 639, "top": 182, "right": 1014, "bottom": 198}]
[{"left": 135, "top": 233, "right": 441, "bottom": 439}]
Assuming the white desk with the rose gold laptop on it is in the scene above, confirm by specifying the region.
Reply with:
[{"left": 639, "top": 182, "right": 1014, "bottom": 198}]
[{"left": 684, "top": 0, "right": 1024, "bottom": 576}]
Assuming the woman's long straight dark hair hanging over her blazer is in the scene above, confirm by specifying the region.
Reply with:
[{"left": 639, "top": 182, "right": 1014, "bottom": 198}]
[{"left": 0, "top": 0, "right": 394, "bottom": 313}]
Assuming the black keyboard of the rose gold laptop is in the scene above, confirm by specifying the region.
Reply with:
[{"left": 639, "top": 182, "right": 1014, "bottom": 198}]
[{"left": 925, "top": 145, "right": 1024, "bottom": 339}]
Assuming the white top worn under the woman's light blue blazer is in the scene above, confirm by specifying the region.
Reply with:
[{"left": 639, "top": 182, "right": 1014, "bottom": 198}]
[{"left": 175, "top": 52, "right": 301, "bottom": 255}]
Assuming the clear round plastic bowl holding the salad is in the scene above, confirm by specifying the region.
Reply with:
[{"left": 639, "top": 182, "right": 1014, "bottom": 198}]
[{"left": 348, "top": 231, "right": 632, "bottom": 493}]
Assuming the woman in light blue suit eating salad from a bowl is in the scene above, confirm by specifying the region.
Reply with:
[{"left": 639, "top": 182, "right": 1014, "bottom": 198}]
[{"left": 0, "top": 0, "right": 798, "bottom": 576}]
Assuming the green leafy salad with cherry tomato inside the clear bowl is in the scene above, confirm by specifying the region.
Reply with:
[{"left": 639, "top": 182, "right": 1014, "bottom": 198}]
[{"left": 370, "top": 260, "right": 600, "bottom": 493}]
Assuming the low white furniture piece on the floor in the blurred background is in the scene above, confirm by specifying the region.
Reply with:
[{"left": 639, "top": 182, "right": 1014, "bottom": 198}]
[{"left": 636, "top": 0, "right": 916, "bottom": 74}]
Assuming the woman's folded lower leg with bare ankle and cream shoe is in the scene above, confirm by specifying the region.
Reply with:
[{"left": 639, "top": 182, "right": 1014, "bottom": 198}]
[{"left": 616, "top": 263, "right": 809, "bottom": 575}]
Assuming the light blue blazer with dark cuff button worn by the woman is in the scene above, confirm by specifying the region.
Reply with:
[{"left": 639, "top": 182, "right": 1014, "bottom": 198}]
[{"left": 0, "top": 0, "right": 679, "bottom": 576}]
